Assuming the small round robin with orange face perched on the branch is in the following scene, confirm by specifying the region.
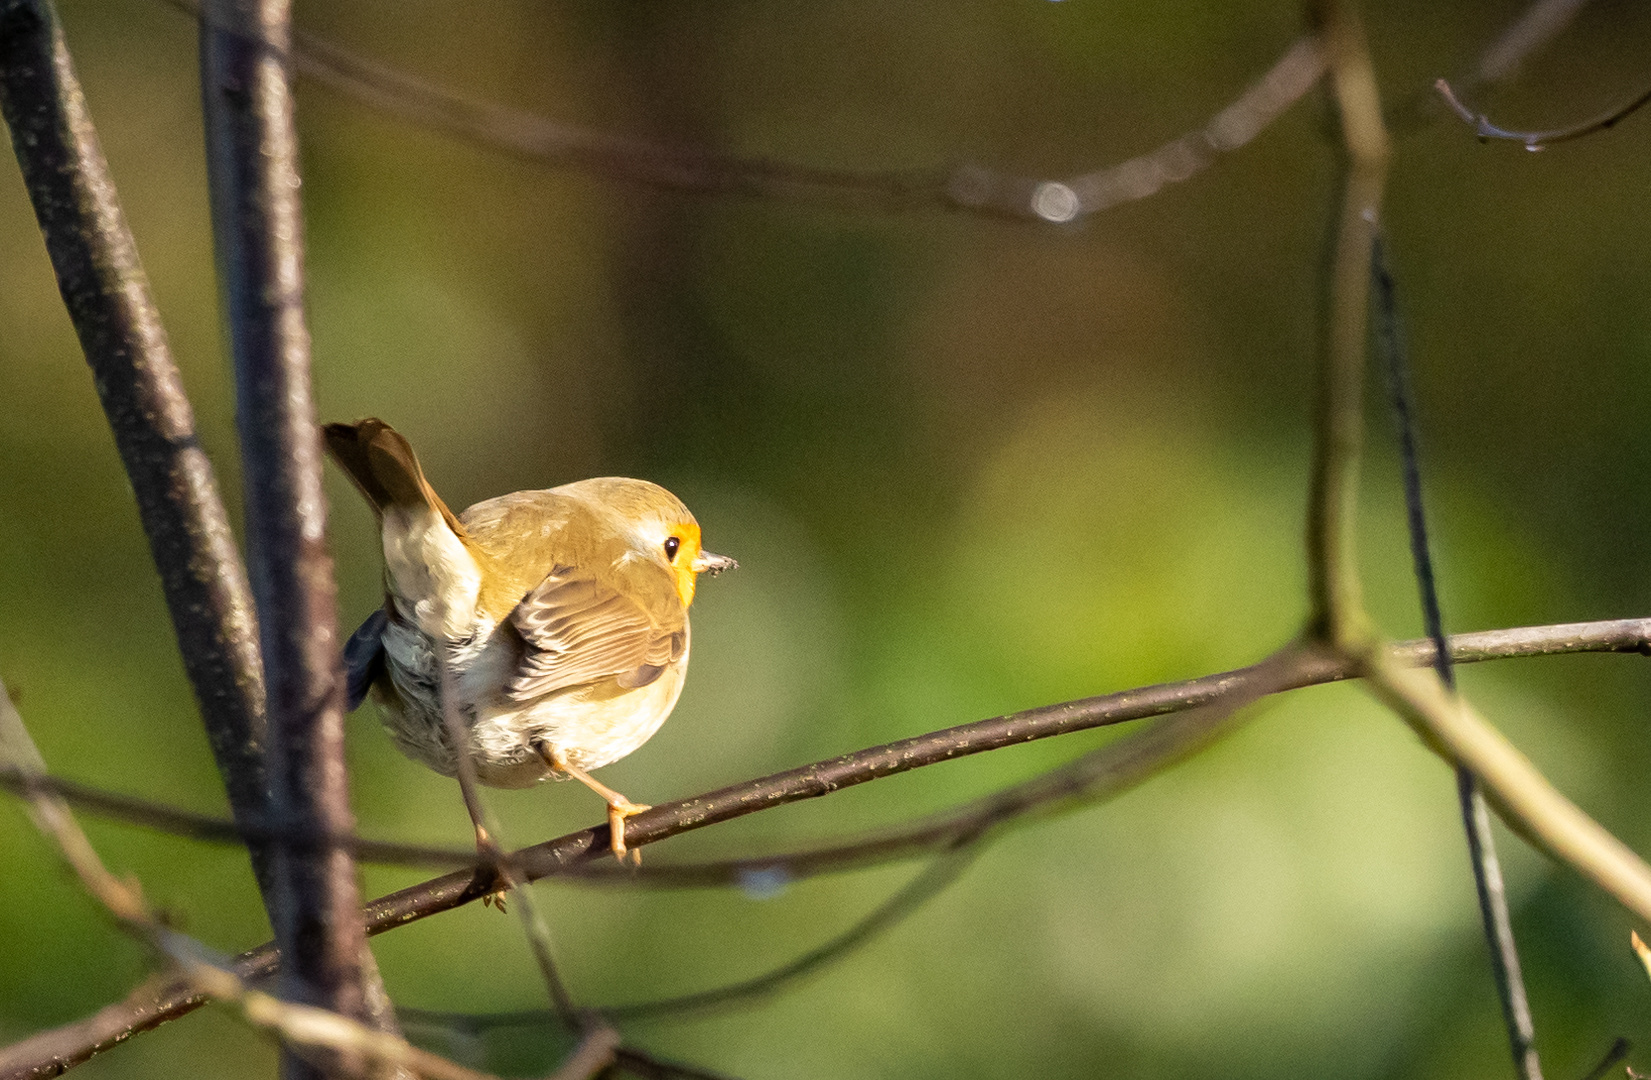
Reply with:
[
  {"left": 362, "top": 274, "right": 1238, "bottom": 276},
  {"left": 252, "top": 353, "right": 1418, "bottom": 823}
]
[{"left": 322, "top": 418, "right": 736, "bottom": 859}]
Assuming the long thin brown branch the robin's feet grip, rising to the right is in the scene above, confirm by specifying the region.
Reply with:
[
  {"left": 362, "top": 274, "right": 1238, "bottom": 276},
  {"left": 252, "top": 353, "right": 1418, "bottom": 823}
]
[{"left": 0, "top": 619, "right": 1651, "bottom": 1080}]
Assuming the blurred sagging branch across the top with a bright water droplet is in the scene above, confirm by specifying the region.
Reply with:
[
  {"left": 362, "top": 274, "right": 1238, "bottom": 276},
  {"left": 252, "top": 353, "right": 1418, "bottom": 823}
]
[{"left": 155, "top": 0, "right": 1324, "bottom": 223}]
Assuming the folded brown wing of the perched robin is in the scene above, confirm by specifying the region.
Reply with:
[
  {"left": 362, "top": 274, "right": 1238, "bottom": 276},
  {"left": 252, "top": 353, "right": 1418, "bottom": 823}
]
[{"left": 505, "top": 566, "right": 688, "bottom": 700}]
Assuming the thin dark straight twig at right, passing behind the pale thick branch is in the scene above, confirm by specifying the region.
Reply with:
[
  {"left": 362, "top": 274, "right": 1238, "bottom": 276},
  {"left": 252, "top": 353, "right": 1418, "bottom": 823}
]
[{"left": 1370, "top": 234, "right": 1542, "bottom": 1080}]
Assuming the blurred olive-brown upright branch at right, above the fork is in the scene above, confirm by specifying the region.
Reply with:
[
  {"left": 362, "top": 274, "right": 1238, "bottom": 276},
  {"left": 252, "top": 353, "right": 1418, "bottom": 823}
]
[{"left": 1308, "top": 2, "right": 1388, "bottom": 649}]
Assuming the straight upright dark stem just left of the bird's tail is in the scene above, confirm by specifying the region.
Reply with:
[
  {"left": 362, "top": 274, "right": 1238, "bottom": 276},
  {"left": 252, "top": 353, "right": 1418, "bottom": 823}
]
[{"left": 201, "top": 0, "right": 367, "bottom": 1077}]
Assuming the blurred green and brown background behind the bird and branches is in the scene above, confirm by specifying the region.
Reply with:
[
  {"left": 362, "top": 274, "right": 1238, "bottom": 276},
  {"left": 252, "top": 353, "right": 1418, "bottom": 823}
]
[{"left": 0, "top": 0, "right": 1651, "bottom": 1078}]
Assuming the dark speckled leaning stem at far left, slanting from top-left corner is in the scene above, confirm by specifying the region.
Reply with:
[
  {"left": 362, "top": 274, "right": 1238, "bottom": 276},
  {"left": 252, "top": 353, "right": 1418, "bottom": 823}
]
[{"left": 0, "top": 0, "right": 271, "bottom": 902}]
